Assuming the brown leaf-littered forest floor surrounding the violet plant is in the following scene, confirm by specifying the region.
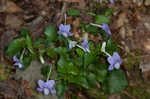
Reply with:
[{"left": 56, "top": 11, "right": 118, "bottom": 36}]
[{"left": 0, "top": 0, "right": 150, "bottom": 99}]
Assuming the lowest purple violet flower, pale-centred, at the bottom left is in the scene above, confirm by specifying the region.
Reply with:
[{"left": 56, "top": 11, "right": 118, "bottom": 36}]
[{"left": 37, "top": 80, "right": 56, "bottom": 95}]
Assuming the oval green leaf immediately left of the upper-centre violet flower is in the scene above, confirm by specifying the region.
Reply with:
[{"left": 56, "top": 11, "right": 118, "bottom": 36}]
[{"left": 44, "top": 25, "right": 57, "bottom": 42}]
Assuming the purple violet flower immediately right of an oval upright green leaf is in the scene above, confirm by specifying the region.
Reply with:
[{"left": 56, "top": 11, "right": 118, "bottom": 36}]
[{"left": 58, "top": 24, "right": 73, "bottom": 37}]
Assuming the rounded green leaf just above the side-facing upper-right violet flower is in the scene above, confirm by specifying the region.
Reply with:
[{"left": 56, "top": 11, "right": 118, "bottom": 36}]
[{"left": 94, "top": 15, "right": 111, "bottom": 24}]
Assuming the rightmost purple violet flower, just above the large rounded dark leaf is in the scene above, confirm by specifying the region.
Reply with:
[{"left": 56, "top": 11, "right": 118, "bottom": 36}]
[{"left": 107, "top": 52, "right": 122, "bottom": 70}]
